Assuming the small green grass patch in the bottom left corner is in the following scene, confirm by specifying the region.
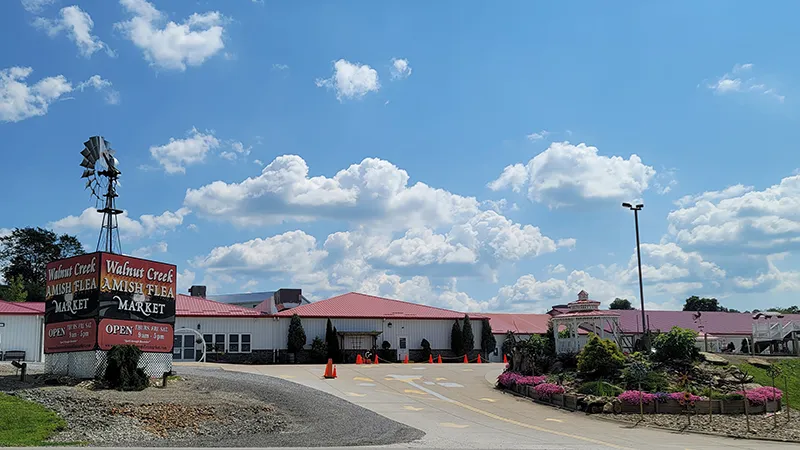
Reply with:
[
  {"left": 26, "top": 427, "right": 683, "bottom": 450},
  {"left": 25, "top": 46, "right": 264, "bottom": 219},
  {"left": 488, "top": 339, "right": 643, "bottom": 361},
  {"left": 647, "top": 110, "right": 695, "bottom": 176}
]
[{"left": 0, "top": 394, "right": 66, "bottom": 446}]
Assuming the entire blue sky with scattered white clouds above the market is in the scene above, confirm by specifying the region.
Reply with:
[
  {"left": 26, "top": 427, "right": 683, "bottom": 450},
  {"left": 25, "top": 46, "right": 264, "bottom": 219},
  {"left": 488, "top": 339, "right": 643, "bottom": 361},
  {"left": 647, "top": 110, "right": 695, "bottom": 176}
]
[{"left": 0, "top": 0, "right": 800, "bottom": 312}]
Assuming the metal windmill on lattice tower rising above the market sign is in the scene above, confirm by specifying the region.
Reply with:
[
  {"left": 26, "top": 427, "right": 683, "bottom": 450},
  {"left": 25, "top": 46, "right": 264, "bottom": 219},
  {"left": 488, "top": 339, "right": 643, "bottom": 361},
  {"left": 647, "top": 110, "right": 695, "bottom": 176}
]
[{"left": 81, "top": 136, "right": 122, "bottom": 254}]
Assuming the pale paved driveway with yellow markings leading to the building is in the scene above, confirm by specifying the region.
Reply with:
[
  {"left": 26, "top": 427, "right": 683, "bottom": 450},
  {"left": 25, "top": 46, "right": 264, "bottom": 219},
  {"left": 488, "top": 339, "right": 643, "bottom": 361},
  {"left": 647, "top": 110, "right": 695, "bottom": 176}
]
[{"left": 183, "top": 364, "right": 797, "bottom": 450}]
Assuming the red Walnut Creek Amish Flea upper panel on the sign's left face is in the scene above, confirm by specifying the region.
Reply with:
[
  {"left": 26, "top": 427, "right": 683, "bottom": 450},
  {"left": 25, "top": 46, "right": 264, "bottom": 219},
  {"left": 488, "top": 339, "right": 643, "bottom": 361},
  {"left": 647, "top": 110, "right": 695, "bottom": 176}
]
[{"left": 45, "top": 253, "right": 100, "bottom": 300}]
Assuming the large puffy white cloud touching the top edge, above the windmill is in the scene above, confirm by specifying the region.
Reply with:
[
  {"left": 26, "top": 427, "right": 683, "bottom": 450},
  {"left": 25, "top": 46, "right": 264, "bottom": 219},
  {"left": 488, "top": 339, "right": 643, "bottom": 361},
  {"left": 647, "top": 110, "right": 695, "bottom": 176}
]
[{"left": 114, "top": 0, "right": 225, "bottom": 71}]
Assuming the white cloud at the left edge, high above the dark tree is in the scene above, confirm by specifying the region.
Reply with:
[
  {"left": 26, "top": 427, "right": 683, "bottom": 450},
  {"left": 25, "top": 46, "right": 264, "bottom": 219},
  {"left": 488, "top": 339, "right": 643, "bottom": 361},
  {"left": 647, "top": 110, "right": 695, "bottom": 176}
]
[{"left": 0, "top": 67, "right": 72, "bottom": 122}]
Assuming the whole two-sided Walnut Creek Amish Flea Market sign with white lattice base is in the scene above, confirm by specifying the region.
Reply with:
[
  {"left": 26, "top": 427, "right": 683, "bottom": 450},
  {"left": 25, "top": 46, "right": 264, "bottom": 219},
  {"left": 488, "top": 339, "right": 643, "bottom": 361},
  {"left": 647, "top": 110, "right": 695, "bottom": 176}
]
[{"left": 44, "top": 252, "right": 177, "bottom": 378}]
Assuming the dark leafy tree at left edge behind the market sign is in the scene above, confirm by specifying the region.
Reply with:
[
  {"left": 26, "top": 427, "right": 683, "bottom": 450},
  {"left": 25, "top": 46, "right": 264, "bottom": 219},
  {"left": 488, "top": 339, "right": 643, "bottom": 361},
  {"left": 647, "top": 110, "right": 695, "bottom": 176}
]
[{"left": 0, "top": 228, "right": 85, "bottom": 301}]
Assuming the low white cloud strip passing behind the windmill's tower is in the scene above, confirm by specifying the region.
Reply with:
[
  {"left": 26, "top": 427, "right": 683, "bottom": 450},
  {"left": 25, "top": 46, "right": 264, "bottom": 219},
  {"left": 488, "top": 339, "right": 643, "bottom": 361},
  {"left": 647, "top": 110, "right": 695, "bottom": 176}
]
[{"left": 48, "top": 208, "right": 191, "bottom": 239}]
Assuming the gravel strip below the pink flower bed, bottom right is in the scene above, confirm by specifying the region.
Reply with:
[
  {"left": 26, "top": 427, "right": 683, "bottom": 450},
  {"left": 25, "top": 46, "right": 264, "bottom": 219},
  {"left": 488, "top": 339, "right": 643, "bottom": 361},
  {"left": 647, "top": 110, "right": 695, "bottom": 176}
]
[{"left": 602, "top": 409, "right": 800, "bottom": 442}]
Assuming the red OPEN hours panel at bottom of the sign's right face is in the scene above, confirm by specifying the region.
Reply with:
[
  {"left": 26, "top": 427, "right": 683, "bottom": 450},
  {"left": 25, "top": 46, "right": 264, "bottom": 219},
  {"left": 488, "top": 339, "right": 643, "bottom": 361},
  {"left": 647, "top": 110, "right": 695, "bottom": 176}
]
[{"left": 97, "top": 319, "right": 174, "bottom": 353}]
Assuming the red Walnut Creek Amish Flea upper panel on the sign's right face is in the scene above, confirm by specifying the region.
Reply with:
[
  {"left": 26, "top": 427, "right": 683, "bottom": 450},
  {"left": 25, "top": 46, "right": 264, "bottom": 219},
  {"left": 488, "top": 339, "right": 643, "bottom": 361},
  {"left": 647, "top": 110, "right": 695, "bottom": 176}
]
[{"left": 100, "top": 253, "right": 178, "bottom": 299}]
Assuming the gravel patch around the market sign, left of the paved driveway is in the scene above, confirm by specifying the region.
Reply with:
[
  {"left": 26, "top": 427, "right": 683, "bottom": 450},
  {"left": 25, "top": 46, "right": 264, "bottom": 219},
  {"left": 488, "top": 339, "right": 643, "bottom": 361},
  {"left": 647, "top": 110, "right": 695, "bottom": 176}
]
[{"left": 0, "top": 367, "right": 424, "bottom": 447}]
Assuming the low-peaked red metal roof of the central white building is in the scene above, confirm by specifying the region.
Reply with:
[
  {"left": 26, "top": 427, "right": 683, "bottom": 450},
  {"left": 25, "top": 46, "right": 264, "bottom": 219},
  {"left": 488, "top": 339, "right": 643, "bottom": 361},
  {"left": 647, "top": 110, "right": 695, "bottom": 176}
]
[{"left": 275, "top": 292, "right": 484, "bottom": 319}]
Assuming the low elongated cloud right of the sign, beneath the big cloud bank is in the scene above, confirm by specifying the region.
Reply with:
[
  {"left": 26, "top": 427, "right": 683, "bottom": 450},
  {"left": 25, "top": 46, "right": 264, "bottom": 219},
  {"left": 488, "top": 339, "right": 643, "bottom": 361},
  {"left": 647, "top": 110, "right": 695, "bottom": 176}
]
[{"left": 194, "top": 230, "right": 327, "bottom": 276}]
